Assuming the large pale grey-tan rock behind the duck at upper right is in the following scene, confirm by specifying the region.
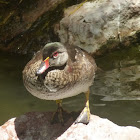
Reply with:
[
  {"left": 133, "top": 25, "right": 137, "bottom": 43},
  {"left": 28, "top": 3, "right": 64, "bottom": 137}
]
[{"left": 59, "top": 0, "right": 140, "bottom": 53}]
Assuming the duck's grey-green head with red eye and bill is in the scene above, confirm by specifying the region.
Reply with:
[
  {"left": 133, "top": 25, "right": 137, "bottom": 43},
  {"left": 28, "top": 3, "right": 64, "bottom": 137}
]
[{"left": 37, "top": 42, "right": 68, "bottom": 75}]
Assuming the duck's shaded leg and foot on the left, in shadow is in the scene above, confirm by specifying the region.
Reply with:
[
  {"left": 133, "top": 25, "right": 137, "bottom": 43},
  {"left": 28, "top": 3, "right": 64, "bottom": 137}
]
[{"left": 51, "top": 100, "right": 64, "bottom": 124}]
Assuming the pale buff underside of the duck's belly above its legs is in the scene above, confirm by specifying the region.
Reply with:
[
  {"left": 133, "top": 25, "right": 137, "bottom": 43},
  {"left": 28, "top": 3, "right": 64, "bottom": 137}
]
[{"left": 26, "top": 80, "right": 93, "bottom": 100}]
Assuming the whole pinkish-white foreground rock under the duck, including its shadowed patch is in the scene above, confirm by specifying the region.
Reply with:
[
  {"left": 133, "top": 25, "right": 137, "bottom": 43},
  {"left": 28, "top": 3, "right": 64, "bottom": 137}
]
[{"left": 0, "top": 112, "right": 140, "bottom": 140}]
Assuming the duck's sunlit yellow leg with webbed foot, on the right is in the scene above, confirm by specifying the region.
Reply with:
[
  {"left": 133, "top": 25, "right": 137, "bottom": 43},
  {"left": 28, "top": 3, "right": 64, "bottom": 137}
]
[{"left": 75, "top": 90, "right": 90, "bottom": 124}]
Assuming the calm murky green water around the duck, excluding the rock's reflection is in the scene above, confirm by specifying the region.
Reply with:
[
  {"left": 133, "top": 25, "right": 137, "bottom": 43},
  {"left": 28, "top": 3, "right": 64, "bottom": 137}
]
[{"left": 0, "top": 50, "right": 140, "bottom": 128}]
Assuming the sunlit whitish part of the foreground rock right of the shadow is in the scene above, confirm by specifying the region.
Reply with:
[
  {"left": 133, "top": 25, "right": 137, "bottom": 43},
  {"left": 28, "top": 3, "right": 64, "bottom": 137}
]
[{"left": 57, "top": 115, "right": 140, "bottom": 140}]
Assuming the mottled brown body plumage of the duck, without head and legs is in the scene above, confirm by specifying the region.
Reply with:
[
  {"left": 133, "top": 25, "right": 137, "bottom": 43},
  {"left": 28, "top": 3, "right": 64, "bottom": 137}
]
[{"left": 23, "top": 42, "right": 96, "bottom": 100}]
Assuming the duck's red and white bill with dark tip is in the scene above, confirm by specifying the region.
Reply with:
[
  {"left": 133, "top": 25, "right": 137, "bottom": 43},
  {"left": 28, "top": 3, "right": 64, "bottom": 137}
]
[{"left": 36, "top": 59, "right": 49, "bottom": 75}]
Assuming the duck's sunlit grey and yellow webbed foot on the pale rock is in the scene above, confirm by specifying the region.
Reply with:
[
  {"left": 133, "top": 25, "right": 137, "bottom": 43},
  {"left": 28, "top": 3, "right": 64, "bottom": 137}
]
[{"left": 75, "top": 107, "right": 90, "bottom": 124}]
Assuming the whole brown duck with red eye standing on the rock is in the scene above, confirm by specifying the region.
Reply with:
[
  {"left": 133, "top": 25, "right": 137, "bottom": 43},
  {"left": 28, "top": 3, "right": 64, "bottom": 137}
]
[{"left": 23, "top": 42, "right": 97, "bottom": 124}]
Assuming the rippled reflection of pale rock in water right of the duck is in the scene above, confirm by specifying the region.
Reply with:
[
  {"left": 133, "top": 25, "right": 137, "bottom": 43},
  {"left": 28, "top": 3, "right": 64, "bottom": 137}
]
[{"left": 92, "top": 47, "right": 140, "bottom": 101}]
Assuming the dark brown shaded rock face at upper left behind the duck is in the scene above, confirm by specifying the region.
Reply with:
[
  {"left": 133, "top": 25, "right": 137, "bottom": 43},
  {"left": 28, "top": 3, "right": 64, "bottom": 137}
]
[{"left": 0, "top": 0, "right": 82, "bottom": 53}]
